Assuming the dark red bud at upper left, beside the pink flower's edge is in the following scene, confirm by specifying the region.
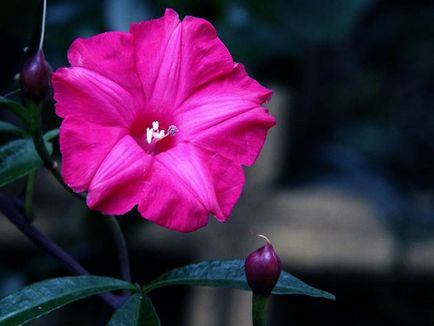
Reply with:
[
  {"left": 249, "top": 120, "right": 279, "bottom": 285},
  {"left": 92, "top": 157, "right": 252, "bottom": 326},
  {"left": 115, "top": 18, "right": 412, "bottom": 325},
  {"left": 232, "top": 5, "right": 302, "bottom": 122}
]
[{"left": 20, "top": 50, "right": 52, "bottom": 101}]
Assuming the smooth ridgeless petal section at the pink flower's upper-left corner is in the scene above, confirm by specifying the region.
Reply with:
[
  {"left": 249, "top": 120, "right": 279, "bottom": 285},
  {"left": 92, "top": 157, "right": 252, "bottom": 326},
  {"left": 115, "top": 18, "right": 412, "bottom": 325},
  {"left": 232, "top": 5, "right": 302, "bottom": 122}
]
[{"left": 68, "top": 32, "right": 143, "bottom": 98}]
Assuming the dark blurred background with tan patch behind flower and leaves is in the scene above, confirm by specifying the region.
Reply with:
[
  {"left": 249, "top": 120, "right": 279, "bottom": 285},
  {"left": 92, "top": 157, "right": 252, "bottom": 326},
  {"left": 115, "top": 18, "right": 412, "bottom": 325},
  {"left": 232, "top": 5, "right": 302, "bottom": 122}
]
[{"left": 0, "top": 0, "right": 434, "bottom": 326}]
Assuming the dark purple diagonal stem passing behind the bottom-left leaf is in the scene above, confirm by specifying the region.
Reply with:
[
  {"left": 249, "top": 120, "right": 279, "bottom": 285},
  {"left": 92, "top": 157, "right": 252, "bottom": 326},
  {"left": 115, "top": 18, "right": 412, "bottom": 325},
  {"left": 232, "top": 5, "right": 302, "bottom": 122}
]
[{"left": 0, "top": 194, "right": 126, "bottom": 309}]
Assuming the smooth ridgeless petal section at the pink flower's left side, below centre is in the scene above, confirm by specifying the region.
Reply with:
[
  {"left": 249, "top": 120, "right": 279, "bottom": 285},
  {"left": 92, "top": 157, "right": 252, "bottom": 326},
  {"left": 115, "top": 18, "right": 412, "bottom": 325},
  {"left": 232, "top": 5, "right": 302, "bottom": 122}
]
[{"left": 60, "top": 117, "right": 127, "bottom": 192}]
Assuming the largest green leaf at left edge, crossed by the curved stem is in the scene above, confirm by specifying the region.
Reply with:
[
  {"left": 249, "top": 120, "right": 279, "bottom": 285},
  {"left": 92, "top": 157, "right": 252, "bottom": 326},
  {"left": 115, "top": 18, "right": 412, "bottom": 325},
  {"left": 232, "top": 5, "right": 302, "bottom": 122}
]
[{"left": 0, "top": 138, "right": 53, "bottom": 187}]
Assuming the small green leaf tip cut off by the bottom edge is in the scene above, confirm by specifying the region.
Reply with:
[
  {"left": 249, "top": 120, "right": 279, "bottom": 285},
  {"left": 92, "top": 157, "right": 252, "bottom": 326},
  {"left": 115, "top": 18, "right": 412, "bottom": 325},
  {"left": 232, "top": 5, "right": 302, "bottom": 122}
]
[{"left": 108, "top": 293, "right": 160, "bottom": 326}]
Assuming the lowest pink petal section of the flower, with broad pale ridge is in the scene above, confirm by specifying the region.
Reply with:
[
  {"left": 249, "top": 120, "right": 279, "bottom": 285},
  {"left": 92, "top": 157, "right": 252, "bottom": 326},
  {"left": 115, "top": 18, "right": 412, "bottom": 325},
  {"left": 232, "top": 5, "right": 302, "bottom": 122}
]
[{"left": 139, "top": 144, "right": 244, "bottom": 232}]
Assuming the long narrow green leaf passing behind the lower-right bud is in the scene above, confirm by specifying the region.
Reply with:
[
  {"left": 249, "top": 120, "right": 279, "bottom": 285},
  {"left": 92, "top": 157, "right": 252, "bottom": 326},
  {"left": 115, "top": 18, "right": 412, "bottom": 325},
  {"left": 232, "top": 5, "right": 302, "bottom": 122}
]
[{"left": 143, "top": 259, "right": 335, "bottom": 300}]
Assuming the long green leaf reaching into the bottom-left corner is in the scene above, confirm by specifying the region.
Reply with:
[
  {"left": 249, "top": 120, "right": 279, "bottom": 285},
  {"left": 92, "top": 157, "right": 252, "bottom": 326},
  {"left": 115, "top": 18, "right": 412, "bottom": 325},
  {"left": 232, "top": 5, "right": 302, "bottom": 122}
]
[{"left": 0, "top": 276, "right": 137, "bottom": 325}]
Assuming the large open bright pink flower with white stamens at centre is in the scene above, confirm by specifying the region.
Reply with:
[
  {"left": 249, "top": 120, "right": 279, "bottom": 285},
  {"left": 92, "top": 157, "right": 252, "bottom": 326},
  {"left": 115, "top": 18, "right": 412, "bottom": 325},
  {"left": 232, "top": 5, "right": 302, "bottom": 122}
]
[{"left": 53, "top": 9, "right": 275, "bottom": 232}]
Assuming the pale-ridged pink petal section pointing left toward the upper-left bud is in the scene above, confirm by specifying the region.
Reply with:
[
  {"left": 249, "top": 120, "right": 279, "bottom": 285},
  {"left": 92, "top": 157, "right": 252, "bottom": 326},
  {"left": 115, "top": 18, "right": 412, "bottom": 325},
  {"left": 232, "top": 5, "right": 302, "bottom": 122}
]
[{"left": 52, "top": 67, "right": 140, "bottom": 128}]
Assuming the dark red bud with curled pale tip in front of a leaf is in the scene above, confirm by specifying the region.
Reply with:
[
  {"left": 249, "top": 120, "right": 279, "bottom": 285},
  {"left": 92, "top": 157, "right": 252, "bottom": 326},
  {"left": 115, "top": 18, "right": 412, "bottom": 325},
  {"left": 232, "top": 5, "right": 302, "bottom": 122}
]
[{"left": 244, "top": 234, "right": 282, "bottom": 295}]
